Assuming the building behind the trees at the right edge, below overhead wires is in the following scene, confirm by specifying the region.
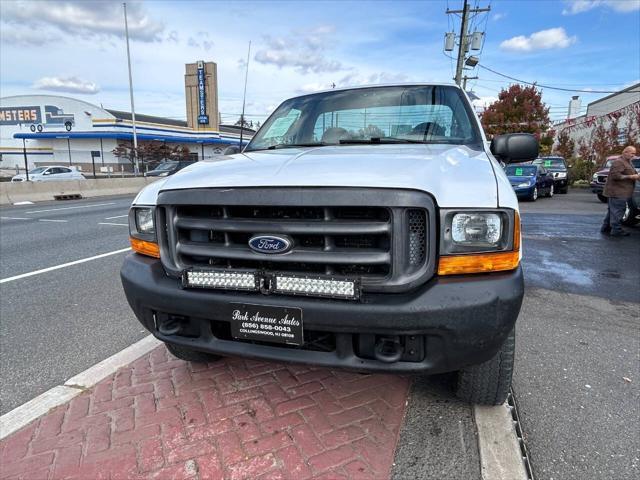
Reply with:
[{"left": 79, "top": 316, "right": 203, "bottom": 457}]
[{"left": 553, "top": 83, "right": 640, "bottom": 158}]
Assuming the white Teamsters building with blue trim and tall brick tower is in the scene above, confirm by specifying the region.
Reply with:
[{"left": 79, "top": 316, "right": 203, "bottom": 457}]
[{"left": 0, "top": 62, "right": 255, "bottom": 173}]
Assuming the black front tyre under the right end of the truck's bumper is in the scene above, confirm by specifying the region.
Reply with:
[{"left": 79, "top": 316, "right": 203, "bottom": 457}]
[{"left": 456, "top": 329, "right": 516, "bottom": 405}]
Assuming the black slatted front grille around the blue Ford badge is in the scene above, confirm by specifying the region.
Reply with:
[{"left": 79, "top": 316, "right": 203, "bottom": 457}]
[{"left": 156, "top": 189, "right": 435, "bottom": 291}]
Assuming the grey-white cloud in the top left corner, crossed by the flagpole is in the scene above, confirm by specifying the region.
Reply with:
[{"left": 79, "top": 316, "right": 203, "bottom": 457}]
[{"left": 2, "top": 0, "right": 164, "bottom": 42}]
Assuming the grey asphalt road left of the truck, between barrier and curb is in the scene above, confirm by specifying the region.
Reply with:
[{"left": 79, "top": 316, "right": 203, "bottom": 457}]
[{"left": 0, "top": 196, "right": 145, "bottom": 413}]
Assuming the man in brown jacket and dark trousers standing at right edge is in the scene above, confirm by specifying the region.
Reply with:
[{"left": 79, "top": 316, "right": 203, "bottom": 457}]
[{"left": 600, "top": 146, "right": 640, "bottom": 237}]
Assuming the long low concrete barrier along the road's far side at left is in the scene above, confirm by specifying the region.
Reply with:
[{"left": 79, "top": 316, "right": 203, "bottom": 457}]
[{"left": 0, "top": 177, "right": 158, "bottom": 205}]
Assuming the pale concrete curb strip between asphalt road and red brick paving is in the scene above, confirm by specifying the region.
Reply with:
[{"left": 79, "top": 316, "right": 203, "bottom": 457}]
[{"left": 0, "top": 335, "right": 162, "bottom": 440}]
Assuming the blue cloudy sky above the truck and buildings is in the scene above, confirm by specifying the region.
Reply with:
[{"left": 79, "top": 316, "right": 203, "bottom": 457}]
[{"left": 0, "top": 0, "right": 640, "bottom": 122}]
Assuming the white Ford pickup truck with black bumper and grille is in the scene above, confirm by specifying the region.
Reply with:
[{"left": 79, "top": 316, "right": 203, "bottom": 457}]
[{"left": 121, "top": 84, "right": 538, "bottom": 404}]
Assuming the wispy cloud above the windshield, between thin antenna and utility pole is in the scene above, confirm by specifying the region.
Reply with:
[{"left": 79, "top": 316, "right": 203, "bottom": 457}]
[{"left": 254, "top": 26, "right": 344, "bottom": 74}]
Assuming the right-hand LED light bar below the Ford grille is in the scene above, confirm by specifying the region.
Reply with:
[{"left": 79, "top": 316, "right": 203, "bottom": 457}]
[{"left": 271, "top": 274, "right": 360, "bottom": 300}]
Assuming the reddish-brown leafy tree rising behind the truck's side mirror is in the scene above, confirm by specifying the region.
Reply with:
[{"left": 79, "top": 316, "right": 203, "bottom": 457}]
[{"left": 481, "top": 84, "right": 549, "bottom": 138}]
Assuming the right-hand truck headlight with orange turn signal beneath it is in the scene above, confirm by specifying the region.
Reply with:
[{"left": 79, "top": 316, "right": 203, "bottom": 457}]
[{"left": 438, "top": 209, "right": 521, "bottom": 275}]
